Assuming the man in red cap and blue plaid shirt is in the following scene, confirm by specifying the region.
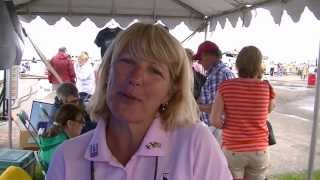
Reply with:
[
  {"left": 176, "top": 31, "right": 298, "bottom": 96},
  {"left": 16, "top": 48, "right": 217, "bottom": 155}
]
[{"left": 193, "top": 41, "right": 235, "bottom": 140}]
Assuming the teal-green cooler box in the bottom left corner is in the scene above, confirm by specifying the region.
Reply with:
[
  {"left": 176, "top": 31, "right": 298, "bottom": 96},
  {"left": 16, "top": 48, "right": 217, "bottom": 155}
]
[{"left": 0, "top": 148, "right": 36, "bottom": 177}]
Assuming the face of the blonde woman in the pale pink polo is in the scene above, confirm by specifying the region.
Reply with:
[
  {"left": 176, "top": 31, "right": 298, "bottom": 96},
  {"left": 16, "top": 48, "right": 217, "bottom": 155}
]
[{"left": 106, "top": 53, "right": 172, "bottom": 123}]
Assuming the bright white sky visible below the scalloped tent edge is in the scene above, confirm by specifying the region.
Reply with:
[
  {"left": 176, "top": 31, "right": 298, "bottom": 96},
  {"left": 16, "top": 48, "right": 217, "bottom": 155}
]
[{"left": 22, "top": 8, "right": 320, "bottom": 63}]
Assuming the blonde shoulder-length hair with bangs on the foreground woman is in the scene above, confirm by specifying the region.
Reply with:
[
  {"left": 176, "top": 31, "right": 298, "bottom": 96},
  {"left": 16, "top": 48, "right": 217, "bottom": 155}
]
[{"left": 91, "top": 23, "right": 199, "bottom": 130}]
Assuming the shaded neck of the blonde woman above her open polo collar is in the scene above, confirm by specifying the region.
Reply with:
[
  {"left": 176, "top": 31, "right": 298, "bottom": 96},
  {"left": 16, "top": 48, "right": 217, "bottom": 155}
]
[{"left": 106, "top": 118, "right": 150, "bottom": 166}]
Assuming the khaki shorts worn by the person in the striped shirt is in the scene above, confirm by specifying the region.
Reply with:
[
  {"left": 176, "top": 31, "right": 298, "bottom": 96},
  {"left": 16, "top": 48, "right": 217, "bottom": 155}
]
[{"left": 223, "top": 148, "right": 269, "bottom": 180}]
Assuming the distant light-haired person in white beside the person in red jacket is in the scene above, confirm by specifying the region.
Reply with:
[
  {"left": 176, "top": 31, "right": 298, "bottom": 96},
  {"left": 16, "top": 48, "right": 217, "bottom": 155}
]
[{"left": 74, "top": 52, "right": 95, "bottom": 95}]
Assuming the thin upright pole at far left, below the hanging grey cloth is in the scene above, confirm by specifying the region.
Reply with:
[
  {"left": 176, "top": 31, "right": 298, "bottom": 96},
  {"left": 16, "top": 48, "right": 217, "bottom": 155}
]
[{"left": 5, "top": 69, "right": 12, "bottom": 148}]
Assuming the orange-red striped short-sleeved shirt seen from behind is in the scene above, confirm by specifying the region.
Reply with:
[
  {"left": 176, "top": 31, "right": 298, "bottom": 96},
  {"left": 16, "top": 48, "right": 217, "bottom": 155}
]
[{"left": 219, "top": 78, "right": 275, "bottom": 152}]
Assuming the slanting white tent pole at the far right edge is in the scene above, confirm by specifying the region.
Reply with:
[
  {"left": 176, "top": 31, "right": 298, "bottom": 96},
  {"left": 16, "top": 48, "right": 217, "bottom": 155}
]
[{"left": 308, "top": 43, "right": 320, "bottom": 180}]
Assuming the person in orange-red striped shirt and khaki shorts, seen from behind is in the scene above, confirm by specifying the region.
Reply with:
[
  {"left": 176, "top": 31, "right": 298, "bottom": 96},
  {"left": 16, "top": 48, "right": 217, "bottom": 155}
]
[{"left": 210, "top": 46, "right": 275, "bottom": 180}]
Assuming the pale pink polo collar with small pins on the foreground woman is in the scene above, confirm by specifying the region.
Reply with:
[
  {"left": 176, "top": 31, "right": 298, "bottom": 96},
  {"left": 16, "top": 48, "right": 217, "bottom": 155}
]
[{"left": 84, "top": 118, "right": 169, "bottom": 162}]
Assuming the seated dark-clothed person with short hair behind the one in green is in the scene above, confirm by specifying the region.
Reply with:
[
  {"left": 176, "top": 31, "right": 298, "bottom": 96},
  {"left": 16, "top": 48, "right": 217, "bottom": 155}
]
[{"left": 48, "top": 83, "right": 96, "bottom": 134}]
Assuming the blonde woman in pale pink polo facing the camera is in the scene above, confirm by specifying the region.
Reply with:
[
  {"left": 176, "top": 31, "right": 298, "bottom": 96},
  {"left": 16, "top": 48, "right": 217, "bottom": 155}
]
[{"left": 46, "top": 23, "right": 232, "bottom": 180}]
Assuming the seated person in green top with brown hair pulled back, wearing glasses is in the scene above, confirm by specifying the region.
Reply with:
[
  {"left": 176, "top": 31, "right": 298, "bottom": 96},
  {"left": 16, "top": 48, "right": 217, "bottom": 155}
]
[{"left": 39, "top": 104, "right": 85, "bottom": 171}]
